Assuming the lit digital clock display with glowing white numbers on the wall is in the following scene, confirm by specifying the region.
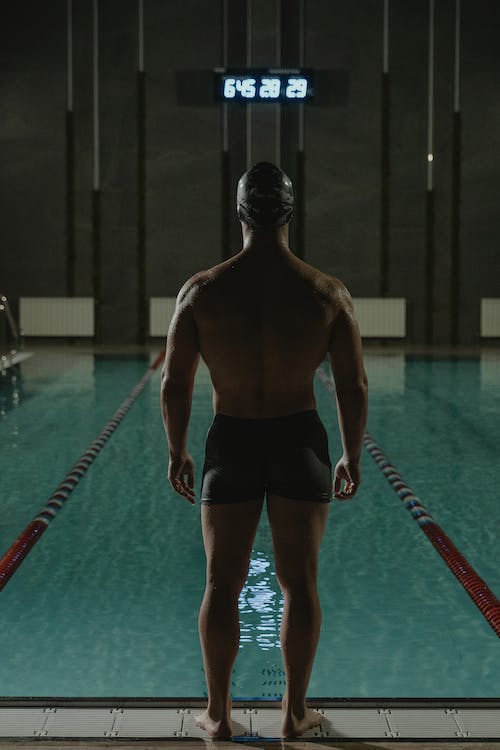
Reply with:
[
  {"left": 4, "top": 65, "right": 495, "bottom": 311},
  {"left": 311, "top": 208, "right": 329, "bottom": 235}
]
[{"left": 214, "top": 68, "right": 314, "bottom": 103}]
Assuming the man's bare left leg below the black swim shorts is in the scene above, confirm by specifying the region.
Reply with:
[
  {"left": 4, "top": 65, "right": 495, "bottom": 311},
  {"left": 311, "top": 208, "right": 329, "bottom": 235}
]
[{"left": 196, "top": 499, "right": 264, "bottom": 738}]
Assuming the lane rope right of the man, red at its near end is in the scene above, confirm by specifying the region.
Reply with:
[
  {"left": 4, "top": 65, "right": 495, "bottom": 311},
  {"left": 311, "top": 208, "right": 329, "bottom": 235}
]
[{"left": 316, "top": 367, "right": 500, "bottom": 638}]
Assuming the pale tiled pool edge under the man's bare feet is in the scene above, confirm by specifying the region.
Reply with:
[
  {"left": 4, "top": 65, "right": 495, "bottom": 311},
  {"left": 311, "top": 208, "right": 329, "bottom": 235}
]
[{"left": 0, "top": 698, "right": 500, "bottom": 750}]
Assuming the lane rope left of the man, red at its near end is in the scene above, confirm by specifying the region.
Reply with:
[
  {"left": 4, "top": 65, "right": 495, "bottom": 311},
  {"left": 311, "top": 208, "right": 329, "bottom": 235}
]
[{"left": 0, "top": 353, "right": 164, "bottom": 591}]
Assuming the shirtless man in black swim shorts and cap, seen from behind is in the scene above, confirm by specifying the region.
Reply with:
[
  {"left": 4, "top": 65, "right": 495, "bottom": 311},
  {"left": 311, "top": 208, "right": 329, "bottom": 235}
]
[{"left": 161, "top": 162, "right": 367, "bottom": 739}]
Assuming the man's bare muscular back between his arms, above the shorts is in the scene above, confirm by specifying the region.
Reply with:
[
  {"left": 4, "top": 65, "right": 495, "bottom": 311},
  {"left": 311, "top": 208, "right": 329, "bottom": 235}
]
[{"left": 192, "top": 248, "right": 340, "bottom": 418}]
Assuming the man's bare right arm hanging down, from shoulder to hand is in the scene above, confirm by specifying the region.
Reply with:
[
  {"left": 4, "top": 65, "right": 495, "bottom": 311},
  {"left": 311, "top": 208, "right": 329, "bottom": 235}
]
[{"left": 328, "top": 282, "right": 368, "bottom": 499}]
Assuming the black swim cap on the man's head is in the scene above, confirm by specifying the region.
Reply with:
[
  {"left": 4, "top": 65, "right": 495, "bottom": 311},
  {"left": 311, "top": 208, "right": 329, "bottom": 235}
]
[{"left": 236, "top": 161, "right": 293, "bottom": 228}]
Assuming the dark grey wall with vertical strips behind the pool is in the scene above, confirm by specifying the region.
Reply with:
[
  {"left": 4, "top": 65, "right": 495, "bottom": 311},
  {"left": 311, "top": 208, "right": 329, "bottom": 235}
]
[{"left": 0, "top": 0, "right": 500, "bottom": 343}]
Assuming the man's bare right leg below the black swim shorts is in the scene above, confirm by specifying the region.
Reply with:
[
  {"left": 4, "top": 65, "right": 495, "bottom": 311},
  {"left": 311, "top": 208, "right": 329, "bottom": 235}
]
[{"left": 267, "top": 494, "right": 329, "bottom": 737}]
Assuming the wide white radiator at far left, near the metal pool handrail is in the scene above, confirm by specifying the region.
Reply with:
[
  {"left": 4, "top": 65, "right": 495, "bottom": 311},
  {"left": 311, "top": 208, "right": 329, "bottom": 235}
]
[{"left": 19, "top": 297, "right": 94, "bottom": 336}]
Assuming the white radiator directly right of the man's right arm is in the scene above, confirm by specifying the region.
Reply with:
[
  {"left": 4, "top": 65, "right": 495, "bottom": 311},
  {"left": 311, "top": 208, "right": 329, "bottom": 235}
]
[{"left": 353, "top": 297, "right": 406, "bottom": 338}]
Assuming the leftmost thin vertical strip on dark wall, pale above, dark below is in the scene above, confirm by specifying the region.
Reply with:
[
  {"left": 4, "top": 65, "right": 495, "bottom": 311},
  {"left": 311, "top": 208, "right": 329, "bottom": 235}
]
[{"left": 66, "top": 0, "right": 75, "bottom": 297}]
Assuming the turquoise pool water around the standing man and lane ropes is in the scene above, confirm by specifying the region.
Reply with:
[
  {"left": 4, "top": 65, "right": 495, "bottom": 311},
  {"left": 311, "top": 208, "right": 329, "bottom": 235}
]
[{"left": 0, "top": 350, "right": 500, "bottom": 697}]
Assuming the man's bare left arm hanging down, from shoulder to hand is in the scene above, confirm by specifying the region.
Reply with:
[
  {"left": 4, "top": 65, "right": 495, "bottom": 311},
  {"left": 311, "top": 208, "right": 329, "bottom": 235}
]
[{"left": 160, "top": 279, "right": 200, "bottom": 506}]
